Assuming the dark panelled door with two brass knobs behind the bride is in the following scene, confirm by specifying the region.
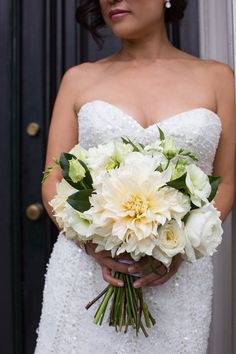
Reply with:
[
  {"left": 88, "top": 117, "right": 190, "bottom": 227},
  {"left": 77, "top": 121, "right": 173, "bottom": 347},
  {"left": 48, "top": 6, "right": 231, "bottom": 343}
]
[{"left": 0, "top": 0, "right": 198, "bottom": 354}]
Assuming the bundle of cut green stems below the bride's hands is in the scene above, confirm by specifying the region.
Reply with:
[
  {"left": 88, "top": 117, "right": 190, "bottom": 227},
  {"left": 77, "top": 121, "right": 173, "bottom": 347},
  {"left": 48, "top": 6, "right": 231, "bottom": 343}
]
[{"left": 85, "top": 272, "right": 156, "bottom": 337}]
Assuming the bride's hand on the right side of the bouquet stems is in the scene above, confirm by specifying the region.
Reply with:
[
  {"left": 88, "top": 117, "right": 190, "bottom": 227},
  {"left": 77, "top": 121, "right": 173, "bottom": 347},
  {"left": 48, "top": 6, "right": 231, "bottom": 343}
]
[{"left": 128, "top": 254, "right": 183, "bottom": 288}]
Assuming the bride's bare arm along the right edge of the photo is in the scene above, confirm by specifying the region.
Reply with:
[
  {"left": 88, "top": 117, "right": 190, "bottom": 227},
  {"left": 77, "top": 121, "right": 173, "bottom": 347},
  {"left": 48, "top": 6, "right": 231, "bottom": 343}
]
[{"left": 213, "top": 63, "right": 236, "bottom": 221}]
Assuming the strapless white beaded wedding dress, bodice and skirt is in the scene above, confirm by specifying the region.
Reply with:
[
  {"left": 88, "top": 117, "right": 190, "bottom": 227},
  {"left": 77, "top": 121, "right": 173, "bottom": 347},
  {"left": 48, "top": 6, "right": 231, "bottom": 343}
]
[{"left": 35, "top": 100, "right": 221, "bottom": 354}]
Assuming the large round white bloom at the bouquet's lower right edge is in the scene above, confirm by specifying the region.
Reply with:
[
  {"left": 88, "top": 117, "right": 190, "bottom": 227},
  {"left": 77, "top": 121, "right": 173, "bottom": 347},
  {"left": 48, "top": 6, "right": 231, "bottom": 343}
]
[{"left": 185, "top": 203, "right": 223, "bottom": 261}]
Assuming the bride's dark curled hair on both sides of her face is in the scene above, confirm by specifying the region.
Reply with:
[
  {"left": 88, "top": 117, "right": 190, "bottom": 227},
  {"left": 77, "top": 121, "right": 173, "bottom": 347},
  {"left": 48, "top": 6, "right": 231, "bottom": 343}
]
[{"left": 76, "top": 0, "right": 187, "bottom": 45}]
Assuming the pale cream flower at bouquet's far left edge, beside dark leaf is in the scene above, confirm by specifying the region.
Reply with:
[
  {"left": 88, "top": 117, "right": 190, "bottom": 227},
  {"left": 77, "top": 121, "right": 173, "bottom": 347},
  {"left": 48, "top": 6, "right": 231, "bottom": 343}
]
[{"left": 48, "top": 179, "right": 77, "bottom": 227}]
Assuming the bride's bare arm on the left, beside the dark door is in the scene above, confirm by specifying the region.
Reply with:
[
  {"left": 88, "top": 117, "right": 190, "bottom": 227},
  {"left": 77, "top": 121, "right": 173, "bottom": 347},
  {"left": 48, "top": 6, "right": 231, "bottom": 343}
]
[{"left": 42, "top": 67, "right": 82, "bottom": 228}]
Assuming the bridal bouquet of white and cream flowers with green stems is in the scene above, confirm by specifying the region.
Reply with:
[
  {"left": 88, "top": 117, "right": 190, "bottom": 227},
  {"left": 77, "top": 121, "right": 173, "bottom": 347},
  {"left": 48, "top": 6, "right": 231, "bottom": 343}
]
[{"left": 43, "top": 128, "right": 222, "bottom": 336}]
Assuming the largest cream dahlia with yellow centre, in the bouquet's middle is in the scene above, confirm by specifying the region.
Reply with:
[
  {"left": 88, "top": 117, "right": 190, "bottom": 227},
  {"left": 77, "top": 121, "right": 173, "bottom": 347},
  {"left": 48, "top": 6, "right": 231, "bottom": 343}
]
[{"left": 84, "top": 162, "right": 186, "bottom": 258}]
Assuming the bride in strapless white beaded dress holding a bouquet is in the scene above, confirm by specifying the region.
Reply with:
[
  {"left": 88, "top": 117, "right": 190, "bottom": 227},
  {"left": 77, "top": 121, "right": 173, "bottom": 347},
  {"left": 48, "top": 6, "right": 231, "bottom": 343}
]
[{"left": 35, "top": 0, "right": 236, "bottom": 354}]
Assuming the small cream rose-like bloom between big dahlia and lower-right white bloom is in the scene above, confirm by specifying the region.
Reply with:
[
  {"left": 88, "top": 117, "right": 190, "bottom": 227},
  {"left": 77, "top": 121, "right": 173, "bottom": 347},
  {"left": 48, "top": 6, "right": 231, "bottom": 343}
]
[{"left": 153, "top": 219, "right": 186, "bottom": 267}]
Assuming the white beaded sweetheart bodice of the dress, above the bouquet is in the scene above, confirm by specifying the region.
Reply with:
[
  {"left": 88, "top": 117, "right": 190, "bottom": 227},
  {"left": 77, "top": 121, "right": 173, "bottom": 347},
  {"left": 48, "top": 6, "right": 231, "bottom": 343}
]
[{"left": 77, "top": 100, "right": 222, "bottom": 174}]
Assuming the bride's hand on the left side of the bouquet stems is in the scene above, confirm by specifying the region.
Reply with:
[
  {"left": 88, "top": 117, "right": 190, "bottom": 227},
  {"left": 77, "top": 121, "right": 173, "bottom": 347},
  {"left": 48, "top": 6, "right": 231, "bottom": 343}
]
[{"left": 85, "top": 241, "right": 135, "bottom": 286}]
